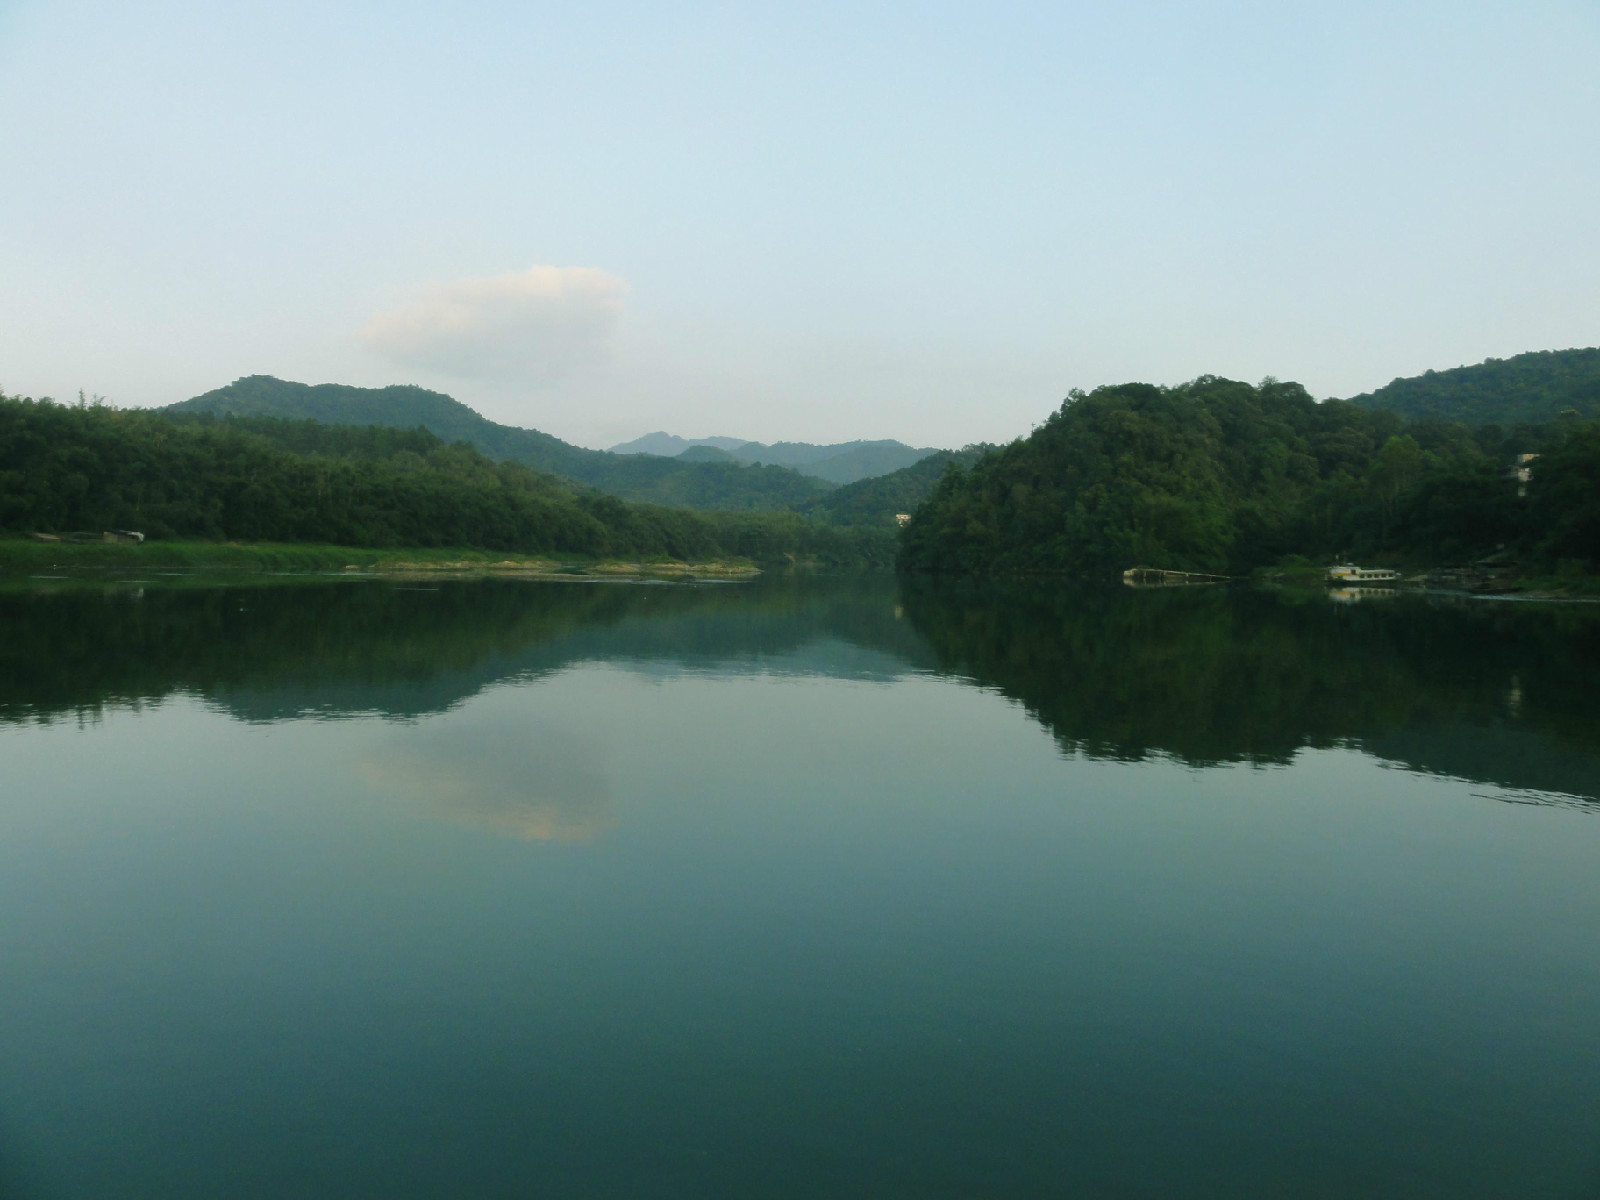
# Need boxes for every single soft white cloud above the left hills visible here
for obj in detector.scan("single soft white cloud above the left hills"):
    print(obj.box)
[360,267,627,382]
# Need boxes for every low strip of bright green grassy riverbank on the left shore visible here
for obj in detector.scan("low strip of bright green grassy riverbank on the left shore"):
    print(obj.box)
[0,538,762,579]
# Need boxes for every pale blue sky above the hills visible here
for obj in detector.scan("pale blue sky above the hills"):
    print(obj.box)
[0,0,1600,445]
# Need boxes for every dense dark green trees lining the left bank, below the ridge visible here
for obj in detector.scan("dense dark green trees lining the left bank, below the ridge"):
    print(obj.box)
[0,397,890,562]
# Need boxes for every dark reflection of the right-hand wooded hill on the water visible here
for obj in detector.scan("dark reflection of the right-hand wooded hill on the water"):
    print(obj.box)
[904,579,1600,809]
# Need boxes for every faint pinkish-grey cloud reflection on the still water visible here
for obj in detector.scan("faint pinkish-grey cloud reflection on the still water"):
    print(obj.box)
[358,722,614,842]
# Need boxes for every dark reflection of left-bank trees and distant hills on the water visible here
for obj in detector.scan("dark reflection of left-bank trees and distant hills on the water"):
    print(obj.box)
[0,576,931,720]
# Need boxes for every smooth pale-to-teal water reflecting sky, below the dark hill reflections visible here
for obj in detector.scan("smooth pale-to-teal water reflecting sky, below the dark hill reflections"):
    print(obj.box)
[0,630,1600,1200]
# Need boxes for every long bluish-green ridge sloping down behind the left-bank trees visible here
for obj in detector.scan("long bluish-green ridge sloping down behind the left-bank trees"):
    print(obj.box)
[170,374,829,509]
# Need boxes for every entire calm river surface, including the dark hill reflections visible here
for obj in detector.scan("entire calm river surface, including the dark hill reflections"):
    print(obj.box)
[0,578,1600,1200]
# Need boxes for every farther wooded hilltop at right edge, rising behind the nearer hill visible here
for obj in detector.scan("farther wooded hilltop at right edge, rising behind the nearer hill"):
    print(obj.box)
[1350,349,1600,426]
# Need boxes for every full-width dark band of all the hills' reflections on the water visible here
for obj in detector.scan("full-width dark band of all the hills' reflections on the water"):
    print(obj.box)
[0,576,1600,812]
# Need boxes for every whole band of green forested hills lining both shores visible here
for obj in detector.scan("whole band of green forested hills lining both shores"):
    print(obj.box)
[9,349,1600,589]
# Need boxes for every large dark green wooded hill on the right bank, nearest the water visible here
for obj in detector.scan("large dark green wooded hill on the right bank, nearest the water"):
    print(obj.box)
[901,376,1600,574]
